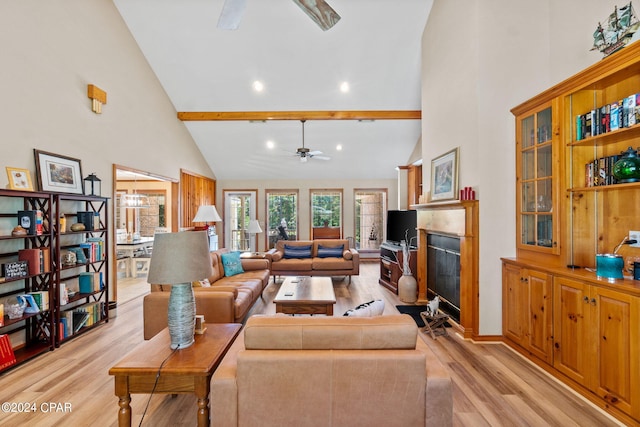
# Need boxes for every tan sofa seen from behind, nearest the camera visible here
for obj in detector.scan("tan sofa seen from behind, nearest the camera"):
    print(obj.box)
[211,315,453,427]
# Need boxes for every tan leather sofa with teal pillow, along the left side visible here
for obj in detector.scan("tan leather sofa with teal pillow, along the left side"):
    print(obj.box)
[143,249,269,340]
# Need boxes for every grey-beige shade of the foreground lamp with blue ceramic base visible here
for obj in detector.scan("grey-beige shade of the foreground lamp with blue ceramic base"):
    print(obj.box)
[147,231,213,285]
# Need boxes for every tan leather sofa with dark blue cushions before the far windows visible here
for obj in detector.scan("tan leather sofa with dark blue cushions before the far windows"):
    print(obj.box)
[267,239,360,282]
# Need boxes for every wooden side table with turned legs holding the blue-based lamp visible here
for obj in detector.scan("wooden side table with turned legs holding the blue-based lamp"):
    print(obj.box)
[109,323,242,427]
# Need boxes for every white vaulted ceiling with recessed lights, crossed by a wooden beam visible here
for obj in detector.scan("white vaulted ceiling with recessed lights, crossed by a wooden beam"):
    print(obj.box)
[114,0,432,180]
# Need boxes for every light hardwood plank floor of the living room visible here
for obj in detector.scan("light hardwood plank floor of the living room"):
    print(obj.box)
[0,263,618,427]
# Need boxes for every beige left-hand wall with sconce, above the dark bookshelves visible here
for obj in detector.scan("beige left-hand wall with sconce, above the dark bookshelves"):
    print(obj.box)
[0,0,213,195]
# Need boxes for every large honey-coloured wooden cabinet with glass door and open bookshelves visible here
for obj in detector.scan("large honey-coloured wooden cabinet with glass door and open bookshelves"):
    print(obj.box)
[503,43,640,425]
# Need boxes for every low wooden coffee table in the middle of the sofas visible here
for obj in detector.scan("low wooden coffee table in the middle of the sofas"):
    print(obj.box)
[273,276,336,316]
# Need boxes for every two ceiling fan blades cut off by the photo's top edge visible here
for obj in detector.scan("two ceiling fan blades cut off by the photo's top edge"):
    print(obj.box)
[218,0,340,31]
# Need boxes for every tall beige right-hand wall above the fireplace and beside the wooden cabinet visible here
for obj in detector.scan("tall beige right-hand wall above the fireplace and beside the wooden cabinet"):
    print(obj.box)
[422,0,619,335]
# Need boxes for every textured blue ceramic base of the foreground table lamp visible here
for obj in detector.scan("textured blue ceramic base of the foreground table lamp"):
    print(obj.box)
[168,283,196,350]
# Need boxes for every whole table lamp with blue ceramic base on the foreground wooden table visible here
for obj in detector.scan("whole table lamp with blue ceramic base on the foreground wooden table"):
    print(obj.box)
[147,231,213,349]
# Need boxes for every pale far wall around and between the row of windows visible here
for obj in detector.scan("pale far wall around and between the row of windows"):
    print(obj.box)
[222,179,398,250]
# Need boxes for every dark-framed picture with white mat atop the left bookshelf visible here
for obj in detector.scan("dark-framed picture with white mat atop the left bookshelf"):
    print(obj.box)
[33,149,84,194]
